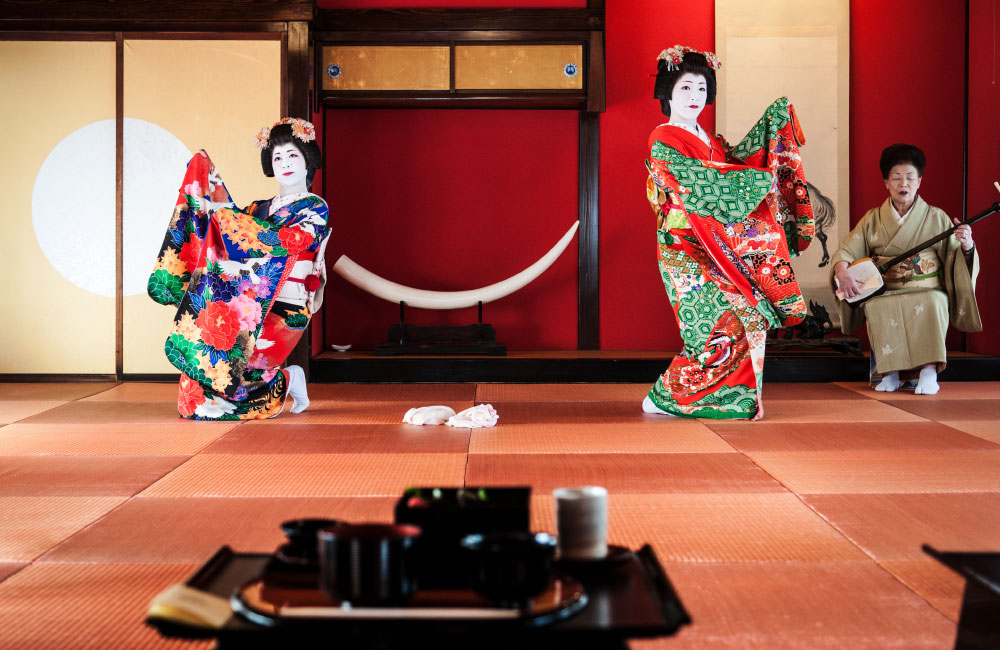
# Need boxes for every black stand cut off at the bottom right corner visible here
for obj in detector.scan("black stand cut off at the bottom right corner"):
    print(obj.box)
[923,544,1000,650]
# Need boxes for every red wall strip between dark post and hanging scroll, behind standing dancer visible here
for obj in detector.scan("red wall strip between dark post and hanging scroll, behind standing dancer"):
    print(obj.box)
[600,0,715,350]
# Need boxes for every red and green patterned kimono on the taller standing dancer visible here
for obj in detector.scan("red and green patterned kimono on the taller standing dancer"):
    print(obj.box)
[646,98,813,419]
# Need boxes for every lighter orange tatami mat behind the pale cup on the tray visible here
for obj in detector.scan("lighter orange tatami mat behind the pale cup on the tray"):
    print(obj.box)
[531,493,867,562]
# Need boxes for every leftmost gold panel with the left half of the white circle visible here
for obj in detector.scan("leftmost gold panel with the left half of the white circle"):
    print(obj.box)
[0,41,115,374]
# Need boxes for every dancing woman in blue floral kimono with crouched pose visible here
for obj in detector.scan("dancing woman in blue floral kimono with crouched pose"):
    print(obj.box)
[147,118,329,420]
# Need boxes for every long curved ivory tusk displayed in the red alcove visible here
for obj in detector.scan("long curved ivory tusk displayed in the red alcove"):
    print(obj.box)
[333,221,580,309]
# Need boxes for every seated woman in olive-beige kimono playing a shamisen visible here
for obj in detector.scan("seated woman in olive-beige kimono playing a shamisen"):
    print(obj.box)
[831,144,983,395]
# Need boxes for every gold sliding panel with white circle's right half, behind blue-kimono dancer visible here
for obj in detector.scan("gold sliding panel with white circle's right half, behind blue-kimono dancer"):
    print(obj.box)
[122,38,282,374]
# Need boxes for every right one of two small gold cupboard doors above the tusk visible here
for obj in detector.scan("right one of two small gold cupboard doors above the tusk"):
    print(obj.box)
[455,45,584,90]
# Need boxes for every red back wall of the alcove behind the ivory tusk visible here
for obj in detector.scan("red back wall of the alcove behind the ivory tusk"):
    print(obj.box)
[312,109,579,350]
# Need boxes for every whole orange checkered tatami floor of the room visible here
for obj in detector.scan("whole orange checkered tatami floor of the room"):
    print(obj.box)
[0,382,1000,650]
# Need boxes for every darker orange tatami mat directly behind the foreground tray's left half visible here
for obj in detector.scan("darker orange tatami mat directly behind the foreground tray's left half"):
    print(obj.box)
[42,497,397,562]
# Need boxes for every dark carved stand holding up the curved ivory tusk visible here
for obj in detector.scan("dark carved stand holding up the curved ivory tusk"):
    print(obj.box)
[375,301,507,357]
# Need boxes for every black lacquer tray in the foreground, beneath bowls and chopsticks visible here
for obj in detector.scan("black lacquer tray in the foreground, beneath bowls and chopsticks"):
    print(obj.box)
[146,546,690,650]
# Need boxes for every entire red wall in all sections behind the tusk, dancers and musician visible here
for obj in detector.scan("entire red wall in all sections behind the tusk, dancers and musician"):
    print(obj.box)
[318,0,1000,354]
